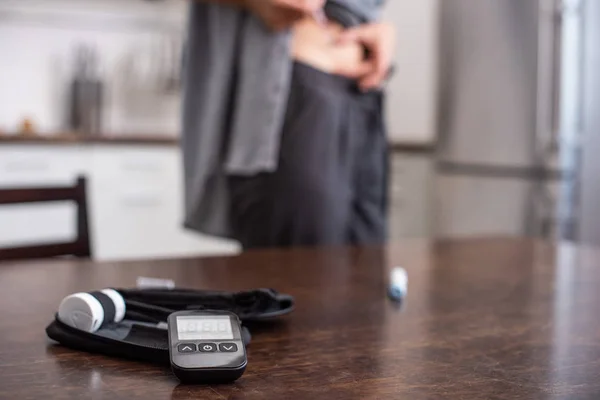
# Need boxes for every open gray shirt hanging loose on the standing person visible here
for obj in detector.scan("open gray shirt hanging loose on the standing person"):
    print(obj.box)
[182,0,382,237]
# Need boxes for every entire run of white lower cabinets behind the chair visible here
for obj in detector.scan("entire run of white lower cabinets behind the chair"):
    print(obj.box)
[0,144,239,260]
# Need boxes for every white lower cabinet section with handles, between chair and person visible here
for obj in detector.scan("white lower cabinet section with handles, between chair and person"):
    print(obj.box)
[90,146,238,259]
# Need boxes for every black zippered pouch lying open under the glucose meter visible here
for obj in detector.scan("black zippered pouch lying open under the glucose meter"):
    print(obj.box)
[46,289,294,364]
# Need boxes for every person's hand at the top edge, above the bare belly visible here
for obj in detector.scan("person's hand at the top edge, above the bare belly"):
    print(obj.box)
[245,0,325,31]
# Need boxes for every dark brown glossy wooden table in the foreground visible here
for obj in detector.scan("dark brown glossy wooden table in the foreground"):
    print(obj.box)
[0,239,600,400]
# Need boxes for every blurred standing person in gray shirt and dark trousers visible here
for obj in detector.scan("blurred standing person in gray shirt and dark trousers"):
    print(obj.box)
[182,0,394,249]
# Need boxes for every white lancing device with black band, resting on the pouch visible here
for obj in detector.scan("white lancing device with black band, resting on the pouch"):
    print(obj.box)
[58,289,125,333]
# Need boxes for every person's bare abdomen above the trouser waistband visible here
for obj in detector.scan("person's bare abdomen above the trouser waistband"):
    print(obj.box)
[292,18,364,74]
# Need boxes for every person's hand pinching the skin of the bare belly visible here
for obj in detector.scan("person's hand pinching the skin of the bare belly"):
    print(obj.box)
[338,23,396,91]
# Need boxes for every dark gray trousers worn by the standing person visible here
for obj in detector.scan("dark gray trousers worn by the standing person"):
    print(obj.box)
[229,63,389,249]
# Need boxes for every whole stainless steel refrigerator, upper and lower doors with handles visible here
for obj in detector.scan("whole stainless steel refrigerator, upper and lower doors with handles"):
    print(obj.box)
[436,0,594,239]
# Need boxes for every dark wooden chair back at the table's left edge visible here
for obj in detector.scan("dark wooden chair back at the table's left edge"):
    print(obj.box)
[0,177,92,261]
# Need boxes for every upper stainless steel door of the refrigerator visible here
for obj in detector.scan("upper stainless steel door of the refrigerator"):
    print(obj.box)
[438,0,554,168]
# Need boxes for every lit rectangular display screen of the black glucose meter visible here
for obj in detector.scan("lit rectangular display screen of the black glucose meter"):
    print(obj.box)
[177,315,233,340]
